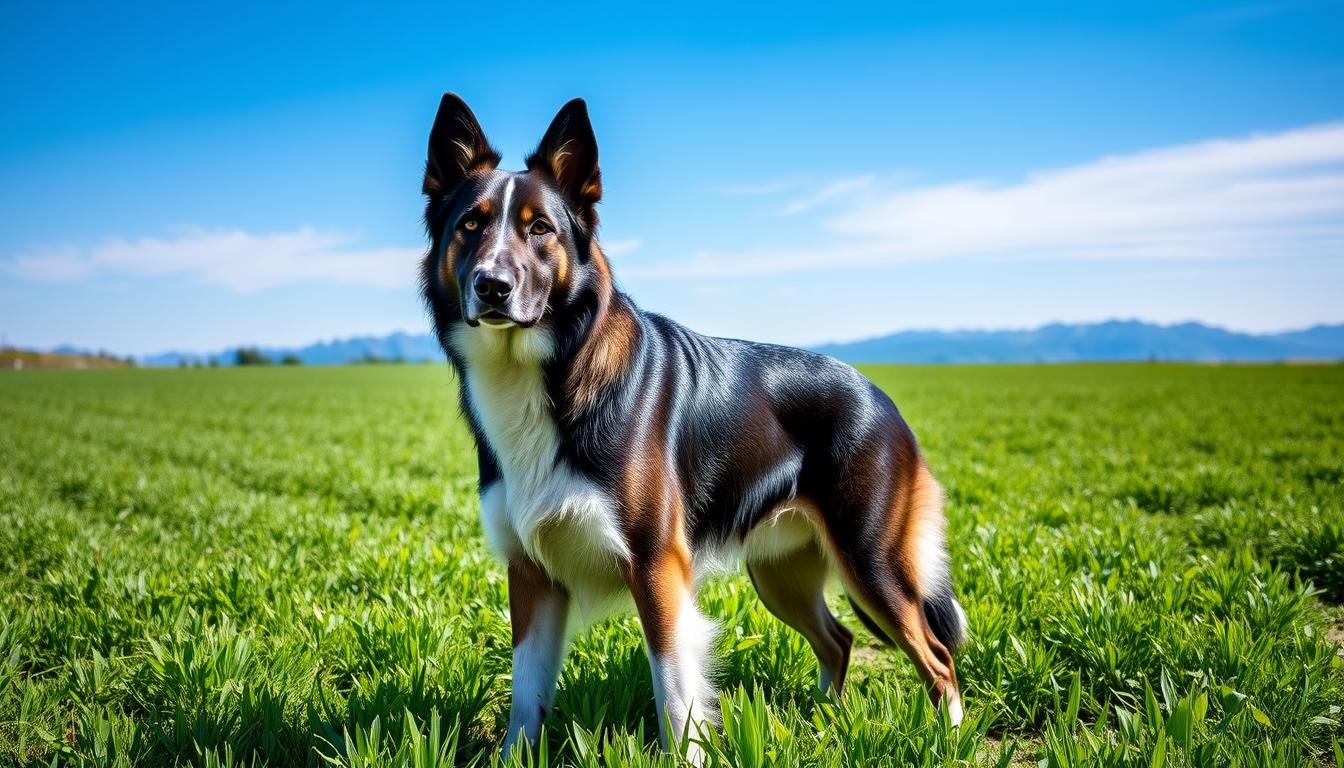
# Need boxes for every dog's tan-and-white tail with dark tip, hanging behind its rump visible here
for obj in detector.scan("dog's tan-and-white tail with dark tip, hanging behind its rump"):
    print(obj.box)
[903,463,966,651]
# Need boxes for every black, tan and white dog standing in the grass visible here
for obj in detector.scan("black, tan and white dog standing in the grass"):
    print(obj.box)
[421,93,966,760]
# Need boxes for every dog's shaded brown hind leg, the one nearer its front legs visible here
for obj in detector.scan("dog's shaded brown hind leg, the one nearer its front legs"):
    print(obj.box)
[747,541,853,695]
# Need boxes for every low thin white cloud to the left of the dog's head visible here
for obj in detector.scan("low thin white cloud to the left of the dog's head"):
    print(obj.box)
[0,227,425,292]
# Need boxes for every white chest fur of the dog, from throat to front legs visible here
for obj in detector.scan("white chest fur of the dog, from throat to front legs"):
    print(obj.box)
[453,325,629,603]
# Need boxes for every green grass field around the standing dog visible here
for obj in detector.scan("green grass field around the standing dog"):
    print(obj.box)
[0,366,1344,768]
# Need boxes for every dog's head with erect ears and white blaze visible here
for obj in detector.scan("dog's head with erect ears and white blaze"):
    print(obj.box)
[423,93,602,328]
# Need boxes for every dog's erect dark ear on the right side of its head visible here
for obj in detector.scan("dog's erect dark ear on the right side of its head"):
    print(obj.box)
[527,98,602,227]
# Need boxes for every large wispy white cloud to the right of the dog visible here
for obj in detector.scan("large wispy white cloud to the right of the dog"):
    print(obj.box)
[626,124,1344,277]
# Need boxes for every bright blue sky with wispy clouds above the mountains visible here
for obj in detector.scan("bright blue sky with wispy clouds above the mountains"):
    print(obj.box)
[0,1,1344,354]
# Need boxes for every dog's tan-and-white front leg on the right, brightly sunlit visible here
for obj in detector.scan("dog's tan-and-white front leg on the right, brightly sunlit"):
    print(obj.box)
[628,550,718,764]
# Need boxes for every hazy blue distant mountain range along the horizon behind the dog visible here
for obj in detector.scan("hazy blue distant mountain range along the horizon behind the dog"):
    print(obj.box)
[52,320,1344,366]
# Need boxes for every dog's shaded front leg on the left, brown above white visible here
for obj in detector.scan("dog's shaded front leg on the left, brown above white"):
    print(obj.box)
[504,557,570,759]
